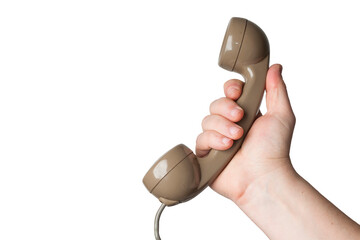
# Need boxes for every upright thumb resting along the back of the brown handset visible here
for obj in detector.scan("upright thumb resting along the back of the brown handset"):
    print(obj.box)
[266,64,294,117]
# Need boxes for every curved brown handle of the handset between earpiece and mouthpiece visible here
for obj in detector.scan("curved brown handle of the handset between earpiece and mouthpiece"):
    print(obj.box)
[198,56,269,189]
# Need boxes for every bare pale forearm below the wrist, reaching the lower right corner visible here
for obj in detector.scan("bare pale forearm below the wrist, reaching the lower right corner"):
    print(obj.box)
[236,164,360,240]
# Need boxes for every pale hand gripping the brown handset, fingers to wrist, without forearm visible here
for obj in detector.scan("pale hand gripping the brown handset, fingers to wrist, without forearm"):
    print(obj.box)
[196,64,295,204]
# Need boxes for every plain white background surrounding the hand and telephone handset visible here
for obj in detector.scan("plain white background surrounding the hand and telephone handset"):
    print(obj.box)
[0,0,360,240]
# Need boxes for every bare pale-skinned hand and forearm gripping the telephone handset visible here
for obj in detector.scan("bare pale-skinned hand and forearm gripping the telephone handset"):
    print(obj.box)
[196,64,360,240]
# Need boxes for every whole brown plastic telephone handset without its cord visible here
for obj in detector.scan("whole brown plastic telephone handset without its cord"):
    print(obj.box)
[143,18,270,206]
